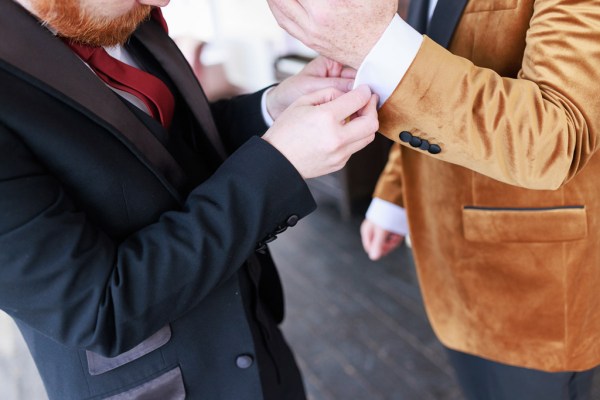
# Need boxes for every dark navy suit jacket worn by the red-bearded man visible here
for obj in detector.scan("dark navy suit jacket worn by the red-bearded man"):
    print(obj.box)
[0,0,314,400]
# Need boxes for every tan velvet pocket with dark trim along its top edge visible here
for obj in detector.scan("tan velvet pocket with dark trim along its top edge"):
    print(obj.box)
[462,206,587,243]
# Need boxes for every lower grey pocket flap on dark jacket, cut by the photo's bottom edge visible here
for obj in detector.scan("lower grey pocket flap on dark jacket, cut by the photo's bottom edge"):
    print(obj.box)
[105,367,185,400]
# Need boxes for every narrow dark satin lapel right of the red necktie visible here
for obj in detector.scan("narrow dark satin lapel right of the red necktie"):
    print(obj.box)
[134,21,227,159]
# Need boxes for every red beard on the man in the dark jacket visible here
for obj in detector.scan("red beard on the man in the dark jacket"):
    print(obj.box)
[33,0,152,46]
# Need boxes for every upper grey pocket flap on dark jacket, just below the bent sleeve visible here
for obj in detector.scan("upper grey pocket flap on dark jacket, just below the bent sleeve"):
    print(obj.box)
[85,325,171,376]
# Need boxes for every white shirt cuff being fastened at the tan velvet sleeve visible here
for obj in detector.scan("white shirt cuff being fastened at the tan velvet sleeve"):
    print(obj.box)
[354,15,423,107]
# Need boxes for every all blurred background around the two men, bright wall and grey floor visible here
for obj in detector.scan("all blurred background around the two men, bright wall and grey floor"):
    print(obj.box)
[0,0,468,400]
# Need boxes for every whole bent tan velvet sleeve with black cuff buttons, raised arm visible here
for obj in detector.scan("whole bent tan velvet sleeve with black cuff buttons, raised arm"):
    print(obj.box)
[380,0,600,189]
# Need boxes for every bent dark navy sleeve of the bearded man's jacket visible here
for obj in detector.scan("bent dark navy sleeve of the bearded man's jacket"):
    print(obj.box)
[0,124,315,356]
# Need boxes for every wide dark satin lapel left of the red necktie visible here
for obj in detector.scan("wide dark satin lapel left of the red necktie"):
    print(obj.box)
[0,0,184,199]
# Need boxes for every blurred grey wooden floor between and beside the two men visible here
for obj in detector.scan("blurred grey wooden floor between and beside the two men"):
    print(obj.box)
[0,195,600,400]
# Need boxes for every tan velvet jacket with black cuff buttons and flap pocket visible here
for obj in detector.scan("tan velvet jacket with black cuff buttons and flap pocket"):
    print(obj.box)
[375,0,600,371]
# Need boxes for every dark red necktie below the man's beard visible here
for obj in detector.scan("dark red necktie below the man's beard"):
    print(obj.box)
[65,8,175,129]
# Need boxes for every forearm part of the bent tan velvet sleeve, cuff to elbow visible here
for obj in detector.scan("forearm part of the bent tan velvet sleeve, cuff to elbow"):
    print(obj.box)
[380,41,600,189]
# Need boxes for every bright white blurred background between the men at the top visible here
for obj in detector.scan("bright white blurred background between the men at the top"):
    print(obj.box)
[163,0,315,98]
